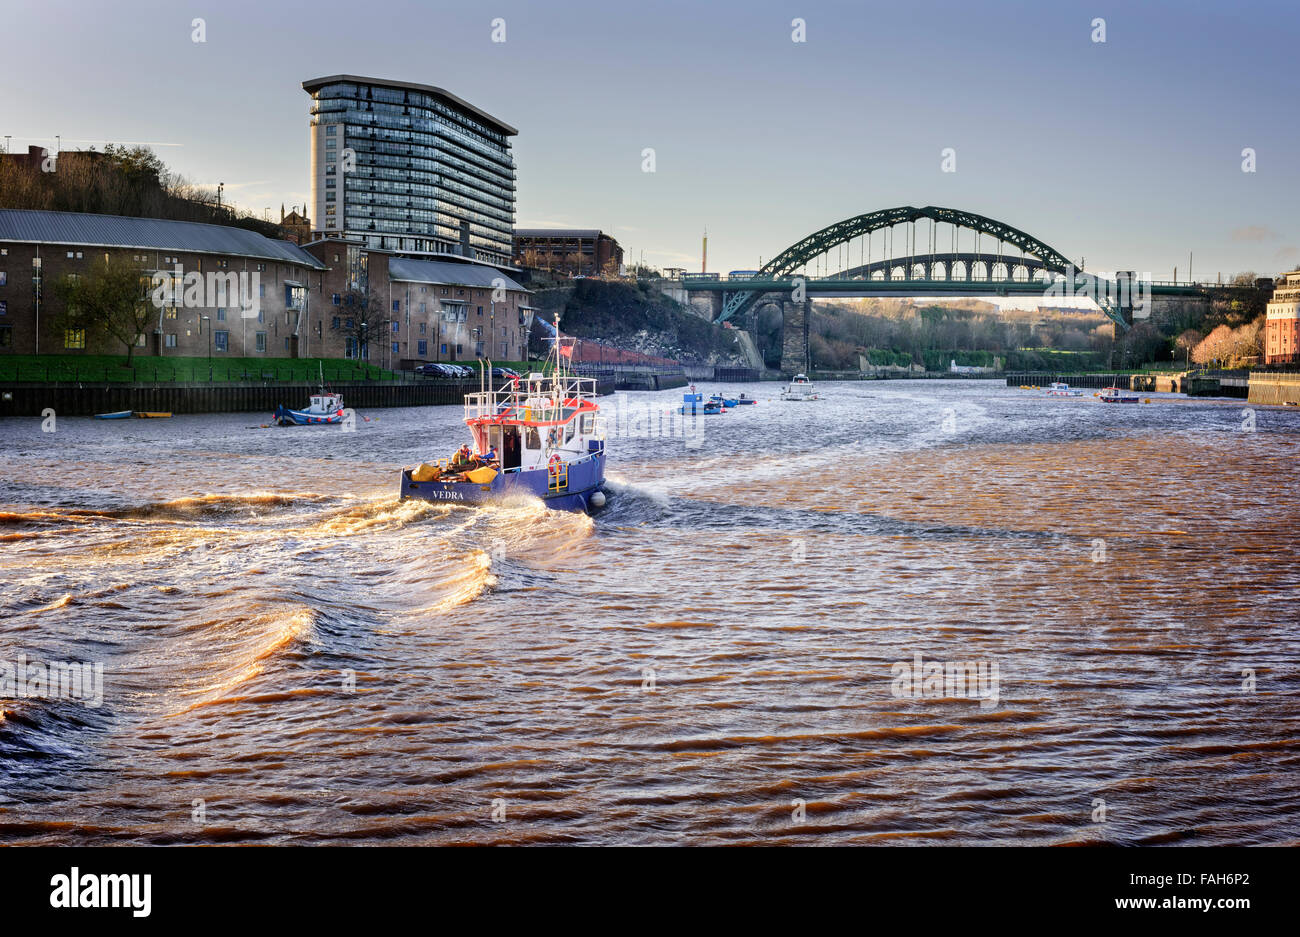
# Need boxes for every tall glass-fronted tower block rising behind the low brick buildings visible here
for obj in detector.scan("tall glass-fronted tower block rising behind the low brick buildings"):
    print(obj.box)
[303,77,515,264]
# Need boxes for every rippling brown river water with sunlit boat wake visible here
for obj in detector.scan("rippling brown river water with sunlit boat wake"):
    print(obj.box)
[0,381,1300,845]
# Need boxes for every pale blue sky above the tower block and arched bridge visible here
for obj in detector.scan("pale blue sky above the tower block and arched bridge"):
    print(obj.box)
[0,0,1300,278]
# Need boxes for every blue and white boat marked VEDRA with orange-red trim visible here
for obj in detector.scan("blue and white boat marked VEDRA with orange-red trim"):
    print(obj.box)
[400,337,605,511]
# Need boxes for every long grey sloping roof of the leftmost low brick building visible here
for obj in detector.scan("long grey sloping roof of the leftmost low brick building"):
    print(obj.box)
[0,208,326,270]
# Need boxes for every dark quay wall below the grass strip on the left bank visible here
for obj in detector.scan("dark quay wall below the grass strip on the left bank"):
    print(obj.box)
[0,381,614,417]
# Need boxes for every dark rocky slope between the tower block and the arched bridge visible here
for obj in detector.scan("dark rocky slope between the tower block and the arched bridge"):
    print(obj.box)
[533,279,745,366]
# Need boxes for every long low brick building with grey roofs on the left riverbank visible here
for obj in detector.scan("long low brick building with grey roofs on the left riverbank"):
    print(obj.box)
[0,211,532,368]
